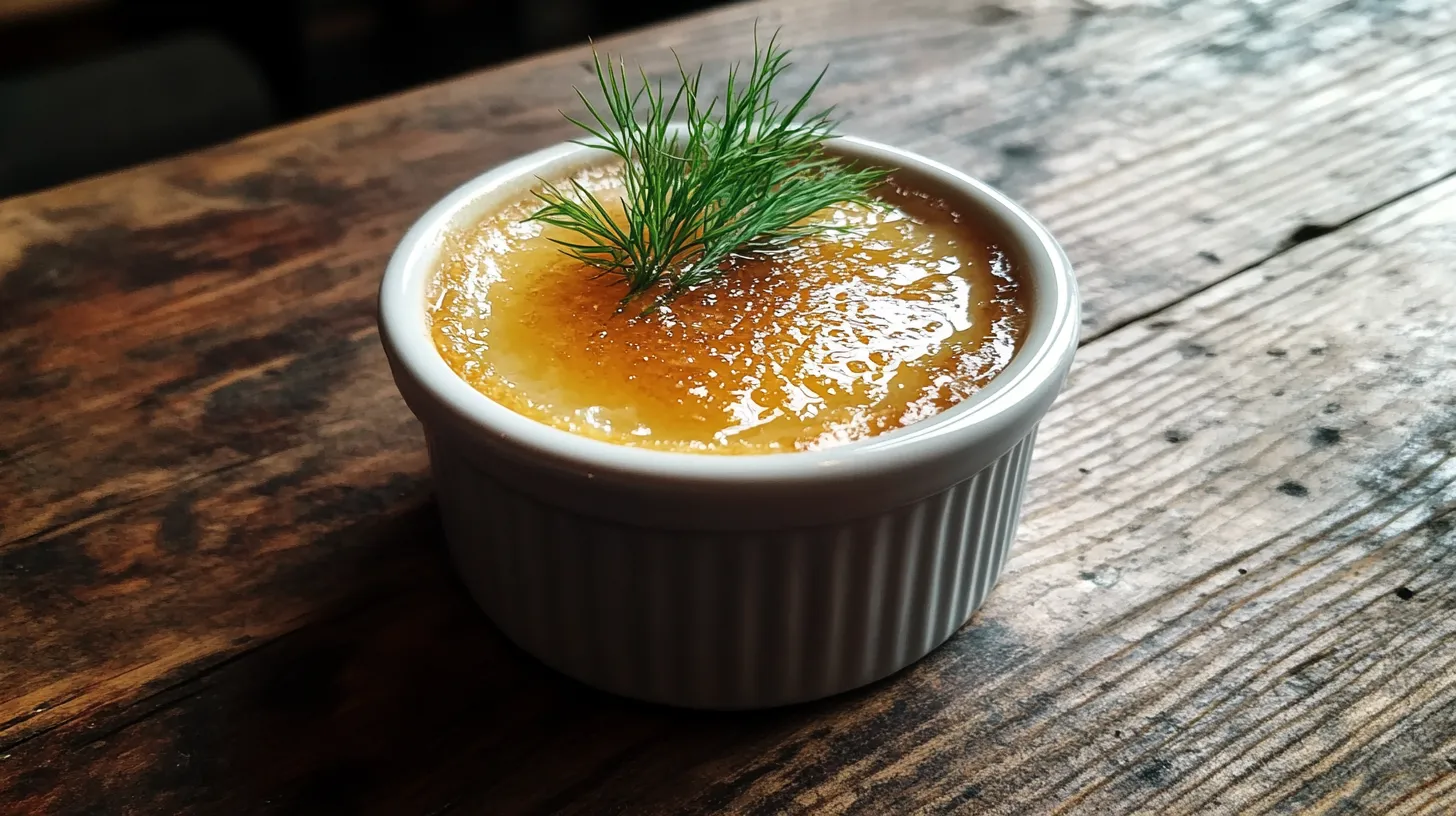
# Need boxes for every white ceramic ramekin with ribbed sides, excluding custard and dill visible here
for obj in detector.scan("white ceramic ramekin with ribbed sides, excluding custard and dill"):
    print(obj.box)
[380,137,1079,708]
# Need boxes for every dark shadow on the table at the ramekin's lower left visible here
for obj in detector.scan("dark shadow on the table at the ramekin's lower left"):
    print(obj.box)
[189,504,879,813]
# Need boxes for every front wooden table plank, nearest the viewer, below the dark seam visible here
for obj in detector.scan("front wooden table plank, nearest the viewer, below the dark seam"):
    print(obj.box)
[0,116,1456,813]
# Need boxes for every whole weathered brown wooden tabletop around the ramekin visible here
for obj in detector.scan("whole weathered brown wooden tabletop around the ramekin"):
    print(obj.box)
[0,0,1456,815]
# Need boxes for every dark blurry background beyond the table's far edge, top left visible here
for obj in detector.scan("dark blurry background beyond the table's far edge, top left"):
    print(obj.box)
[0,0,722,197]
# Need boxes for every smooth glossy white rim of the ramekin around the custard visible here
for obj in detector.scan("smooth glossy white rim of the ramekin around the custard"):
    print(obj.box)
[379,136,1079,485]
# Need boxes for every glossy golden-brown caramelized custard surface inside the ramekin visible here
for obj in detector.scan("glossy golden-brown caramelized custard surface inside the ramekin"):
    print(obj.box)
[428,168,1026,453]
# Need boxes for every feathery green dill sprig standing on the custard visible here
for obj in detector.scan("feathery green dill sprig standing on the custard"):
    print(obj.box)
[531,35,885,310]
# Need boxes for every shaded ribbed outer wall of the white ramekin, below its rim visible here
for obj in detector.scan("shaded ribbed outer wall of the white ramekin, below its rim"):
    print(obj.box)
[431,433,1035,708]
